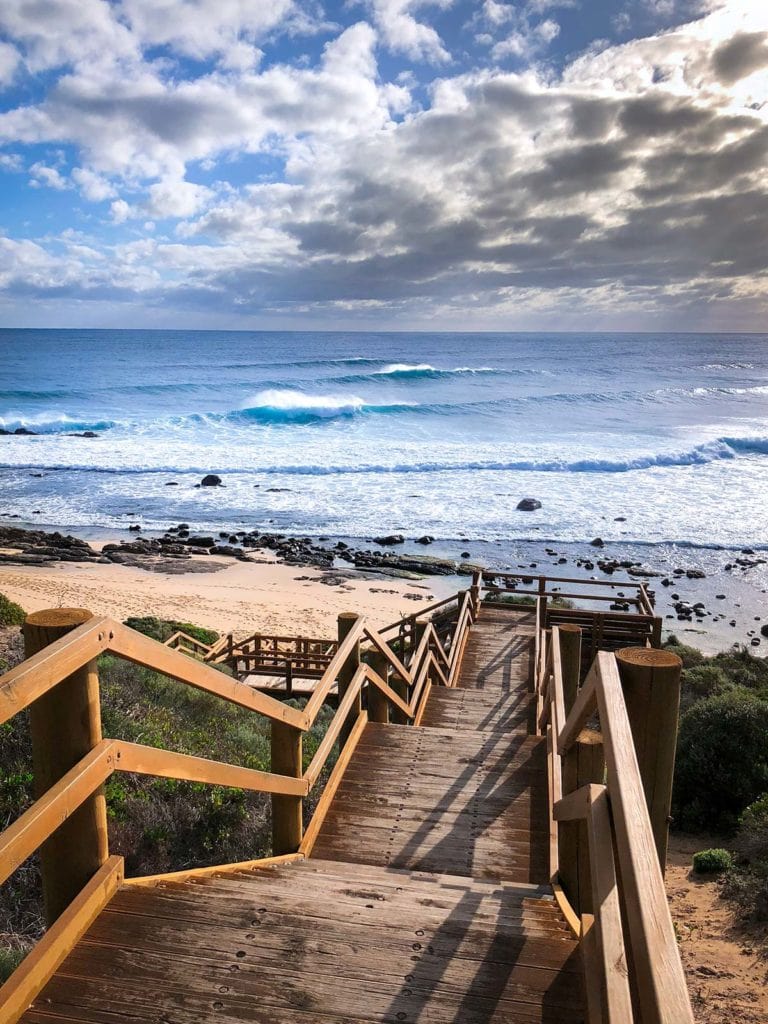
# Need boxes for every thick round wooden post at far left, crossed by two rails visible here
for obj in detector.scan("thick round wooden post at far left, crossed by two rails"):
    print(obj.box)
[24,608,109,925]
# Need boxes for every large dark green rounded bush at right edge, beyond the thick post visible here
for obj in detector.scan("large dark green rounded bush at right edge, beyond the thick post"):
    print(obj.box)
[673,687,768,833]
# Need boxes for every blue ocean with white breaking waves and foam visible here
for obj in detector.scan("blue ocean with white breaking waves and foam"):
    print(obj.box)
[0,330,768,548]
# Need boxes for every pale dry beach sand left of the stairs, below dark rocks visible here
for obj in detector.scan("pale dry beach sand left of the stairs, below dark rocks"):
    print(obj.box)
[0,553,455,637]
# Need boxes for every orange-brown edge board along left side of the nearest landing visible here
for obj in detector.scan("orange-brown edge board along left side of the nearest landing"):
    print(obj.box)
[0,857,123,1024]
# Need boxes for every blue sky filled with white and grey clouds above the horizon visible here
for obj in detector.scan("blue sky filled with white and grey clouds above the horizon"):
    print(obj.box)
[0,0,768,331]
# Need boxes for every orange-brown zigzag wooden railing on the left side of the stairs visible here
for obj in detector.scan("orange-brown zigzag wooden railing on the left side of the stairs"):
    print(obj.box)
[0,592,473,1024]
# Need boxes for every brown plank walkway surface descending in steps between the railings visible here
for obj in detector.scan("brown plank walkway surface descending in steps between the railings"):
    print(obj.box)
[22,608,585,1024]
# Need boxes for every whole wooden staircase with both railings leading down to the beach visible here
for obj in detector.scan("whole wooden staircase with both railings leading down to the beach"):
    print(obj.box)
[0,574,693,1024]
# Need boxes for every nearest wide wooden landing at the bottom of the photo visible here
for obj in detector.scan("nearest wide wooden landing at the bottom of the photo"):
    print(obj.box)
[23,860,584,1024]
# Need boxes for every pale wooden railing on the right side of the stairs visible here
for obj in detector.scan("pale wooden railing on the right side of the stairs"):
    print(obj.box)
[536,606,693,1024]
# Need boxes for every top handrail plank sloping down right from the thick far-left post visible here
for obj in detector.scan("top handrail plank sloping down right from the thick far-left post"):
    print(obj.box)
[108,621,311,729]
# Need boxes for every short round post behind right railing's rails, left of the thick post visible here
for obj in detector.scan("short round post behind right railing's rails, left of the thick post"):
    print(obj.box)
[558,729,605,913]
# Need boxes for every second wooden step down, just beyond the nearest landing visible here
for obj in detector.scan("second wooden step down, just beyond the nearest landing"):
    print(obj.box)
[313,723,549,884]
